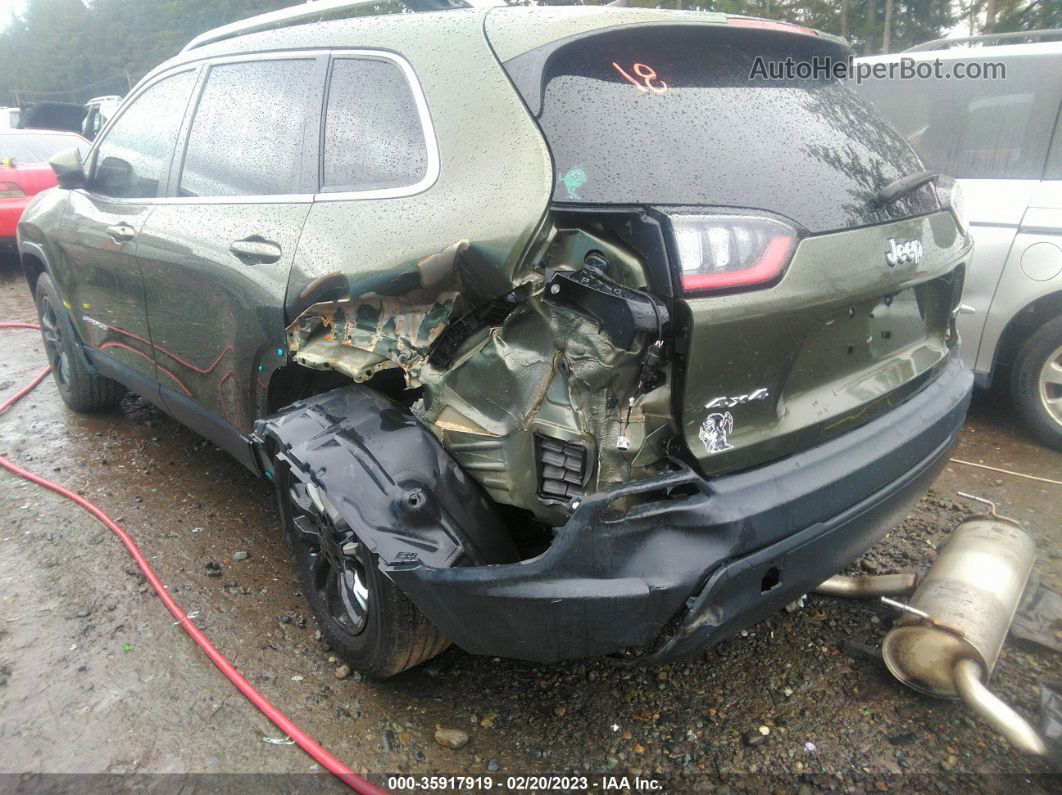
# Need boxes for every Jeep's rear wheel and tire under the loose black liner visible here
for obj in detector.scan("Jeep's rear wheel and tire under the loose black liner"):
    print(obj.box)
[274,462,450,678]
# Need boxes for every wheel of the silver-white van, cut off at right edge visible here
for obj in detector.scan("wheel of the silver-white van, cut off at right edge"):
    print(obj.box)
[1011,317,1062,450]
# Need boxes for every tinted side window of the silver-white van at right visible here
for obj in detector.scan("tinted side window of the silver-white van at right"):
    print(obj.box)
[856,53,1062,179]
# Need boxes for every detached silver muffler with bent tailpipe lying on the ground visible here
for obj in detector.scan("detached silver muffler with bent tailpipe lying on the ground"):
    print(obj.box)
[879,503,1046,755]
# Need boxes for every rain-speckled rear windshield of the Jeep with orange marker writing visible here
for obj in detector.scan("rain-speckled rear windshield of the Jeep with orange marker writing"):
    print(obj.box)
[506,25,938,232]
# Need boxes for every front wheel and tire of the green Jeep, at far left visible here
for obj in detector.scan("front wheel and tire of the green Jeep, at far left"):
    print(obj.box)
[33,273,125,412]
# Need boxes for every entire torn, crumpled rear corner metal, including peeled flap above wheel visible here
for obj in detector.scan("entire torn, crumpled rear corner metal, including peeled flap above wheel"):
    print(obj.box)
[288,225,676,524]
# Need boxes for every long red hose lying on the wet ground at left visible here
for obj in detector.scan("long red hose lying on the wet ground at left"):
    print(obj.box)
[0,323,386,795]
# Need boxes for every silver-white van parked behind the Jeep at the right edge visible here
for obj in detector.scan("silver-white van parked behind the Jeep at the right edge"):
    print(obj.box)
[853,31,1062,449]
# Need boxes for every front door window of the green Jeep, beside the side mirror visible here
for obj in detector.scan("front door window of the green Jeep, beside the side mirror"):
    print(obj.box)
[89,71,195,198]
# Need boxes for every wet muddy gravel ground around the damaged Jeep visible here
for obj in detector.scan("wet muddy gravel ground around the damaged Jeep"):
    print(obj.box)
[0,269,1062,792]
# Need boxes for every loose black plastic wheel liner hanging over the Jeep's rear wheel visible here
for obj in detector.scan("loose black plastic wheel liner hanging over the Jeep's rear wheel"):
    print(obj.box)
[254,384,518,574]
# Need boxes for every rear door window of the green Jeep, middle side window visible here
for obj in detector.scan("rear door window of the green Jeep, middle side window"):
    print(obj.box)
[177,58,319,196]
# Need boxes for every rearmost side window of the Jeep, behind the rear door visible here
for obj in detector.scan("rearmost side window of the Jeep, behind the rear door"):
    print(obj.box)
[322,57,428,192]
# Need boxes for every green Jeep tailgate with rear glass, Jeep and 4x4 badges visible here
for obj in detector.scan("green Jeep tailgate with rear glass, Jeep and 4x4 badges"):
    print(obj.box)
[487,14,969,473]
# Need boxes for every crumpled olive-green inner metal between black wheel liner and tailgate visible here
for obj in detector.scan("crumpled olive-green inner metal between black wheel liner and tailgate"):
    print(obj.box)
[421,292,671,523]
